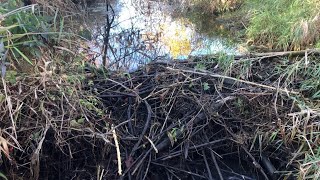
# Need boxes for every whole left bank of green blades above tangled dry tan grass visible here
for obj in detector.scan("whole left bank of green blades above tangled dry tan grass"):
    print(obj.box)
[0,0,101,179]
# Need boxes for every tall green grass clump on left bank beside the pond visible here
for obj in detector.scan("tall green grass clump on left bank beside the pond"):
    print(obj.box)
[0,0,85,73]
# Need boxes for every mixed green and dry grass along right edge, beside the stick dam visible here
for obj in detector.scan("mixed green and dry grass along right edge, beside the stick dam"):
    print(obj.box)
[275,55,320,180]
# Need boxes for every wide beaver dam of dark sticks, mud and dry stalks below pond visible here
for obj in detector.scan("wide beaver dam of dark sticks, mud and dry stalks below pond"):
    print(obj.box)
[2,50,319,179]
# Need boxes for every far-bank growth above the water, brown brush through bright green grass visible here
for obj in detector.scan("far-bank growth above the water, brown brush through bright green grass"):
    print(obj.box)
[175,0,320,50]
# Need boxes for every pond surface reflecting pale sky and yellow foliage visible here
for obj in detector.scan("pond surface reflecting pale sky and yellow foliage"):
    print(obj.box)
[84,0,238,70]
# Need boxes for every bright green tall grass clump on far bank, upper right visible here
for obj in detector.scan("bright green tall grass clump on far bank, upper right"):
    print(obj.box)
[243,0,320,50]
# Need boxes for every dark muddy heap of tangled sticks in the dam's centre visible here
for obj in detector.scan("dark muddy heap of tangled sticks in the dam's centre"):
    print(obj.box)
[87,58,296,179]
